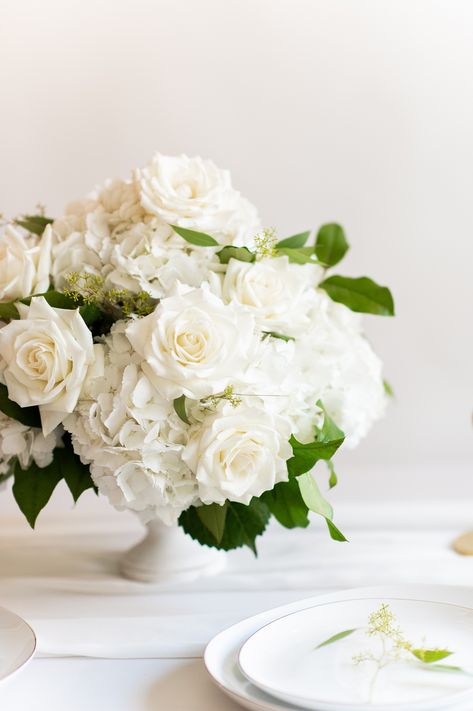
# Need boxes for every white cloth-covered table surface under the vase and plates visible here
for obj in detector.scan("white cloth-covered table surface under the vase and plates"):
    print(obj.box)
[0,501,473,711]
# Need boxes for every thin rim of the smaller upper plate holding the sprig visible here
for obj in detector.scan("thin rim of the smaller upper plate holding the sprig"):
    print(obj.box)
[236,596,473,711]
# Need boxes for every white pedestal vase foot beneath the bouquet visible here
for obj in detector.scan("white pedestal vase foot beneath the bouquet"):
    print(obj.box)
[120,521,226,583]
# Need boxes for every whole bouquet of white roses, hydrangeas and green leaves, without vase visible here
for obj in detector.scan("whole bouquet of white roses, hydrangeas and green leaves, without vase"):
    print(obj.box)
[0,154,394,550]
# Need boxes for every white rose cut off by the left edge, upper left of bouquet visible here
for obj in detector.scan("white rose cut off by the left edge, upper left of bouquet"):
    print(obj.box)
[0,225,52,301]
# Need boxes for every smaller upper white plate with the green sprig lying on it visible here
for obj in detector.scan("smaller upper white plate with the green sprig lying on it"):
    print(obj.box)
[239,597,473,711]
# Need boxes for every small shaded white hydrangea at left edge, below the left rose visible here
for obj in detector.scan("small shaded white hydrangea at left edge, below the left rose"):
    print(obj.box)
[0,412,61,475]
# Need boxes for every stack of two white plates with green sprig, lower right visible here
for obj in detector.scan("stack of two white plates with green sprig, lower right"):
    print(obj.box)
[205,586,473,711]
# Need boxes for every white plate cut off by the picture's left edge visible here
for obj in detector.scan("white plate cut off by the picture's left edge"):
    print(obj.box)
[0,607,36,683]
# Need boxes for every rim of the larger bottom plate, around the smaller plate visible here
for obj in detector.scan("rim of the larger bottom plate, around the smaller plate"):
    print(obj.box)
[203,582,473,711]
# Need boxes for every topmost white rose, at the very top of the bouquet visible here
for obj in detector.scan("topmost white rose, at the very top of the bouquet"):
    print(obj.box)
[137,153,240,233]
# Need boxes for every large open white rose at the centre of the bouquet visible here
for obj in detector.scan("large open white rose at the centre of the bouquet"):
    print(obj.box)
[127,288,258,399]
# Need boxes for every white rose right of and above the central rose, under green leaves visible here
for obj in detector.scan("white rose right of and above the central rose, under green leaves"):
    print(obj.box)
[222,257,321,335]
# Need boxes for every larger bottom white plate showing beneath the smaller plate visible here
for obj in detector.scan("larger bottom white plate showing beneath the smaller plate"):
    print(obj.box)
[204,585,473,711]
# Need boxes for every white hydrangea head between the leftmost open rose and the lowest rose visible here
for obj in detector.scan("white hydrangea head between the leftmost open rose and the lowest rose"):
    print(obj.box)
[65,322,197,524]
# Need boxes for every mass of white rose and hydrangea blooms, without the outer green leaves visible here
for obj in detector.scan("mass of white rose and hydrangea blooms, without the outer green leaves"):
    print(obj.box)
[0,154,385,524]
